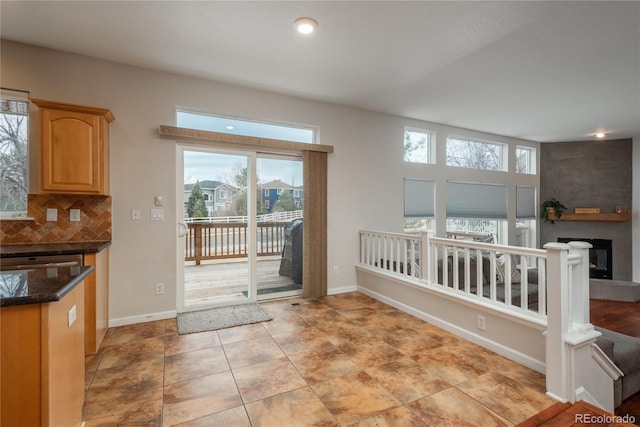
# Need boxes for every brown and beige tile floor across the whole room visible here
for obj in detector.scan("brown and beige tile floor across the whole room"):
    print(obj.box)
[84,292,554,427]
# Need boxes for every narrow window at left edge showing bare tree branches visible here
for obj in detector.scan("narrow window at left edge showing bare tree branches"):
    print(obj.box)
[0,95,29,217]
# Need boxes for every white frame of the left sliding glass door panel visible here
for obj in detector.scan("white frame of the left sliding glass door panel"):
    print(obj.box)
[176,145,257,313]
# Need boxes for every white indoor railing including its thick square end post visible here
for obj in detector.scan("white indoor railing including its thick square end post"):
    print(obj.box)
[358,230,621,412]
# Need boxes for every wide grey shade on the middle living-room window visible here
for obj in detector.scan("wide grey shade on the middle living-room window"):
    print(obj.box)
[447,182,507,219]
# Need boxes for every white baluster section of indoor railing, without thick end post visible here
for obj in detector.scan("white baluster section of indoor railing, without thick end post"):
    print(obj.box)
[360,230,546,316]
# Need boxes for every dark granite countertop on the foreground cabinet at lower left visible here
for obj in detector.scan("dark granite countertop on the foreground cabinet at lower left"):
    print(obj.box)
[0,266,94,307]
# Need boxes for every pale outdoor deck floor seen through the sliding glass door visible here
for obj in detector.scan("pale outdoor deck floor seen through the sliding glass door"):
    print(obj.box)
[184,256,302,306]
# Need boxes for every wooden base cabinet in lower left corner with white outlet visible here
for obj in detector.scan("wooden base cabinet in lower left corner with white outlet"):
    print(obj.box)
[0,283,85,427]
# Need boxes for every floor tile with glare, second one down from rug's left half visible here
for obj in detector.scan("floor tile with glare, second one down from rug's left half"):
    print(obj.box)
[164,346,231,385]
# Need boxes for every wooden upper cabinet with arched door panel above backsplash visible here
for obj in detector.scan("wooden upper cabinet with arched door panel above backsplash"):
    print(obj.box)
[31,99,114,194]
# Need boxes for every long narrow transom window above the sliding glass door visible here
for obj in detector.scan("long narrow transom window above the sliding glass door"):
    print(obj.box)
[176,111,316,144]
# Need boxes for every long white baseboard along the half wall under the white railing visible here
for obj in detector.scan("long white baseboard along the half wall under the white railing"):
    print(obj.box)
[358,287,546,374]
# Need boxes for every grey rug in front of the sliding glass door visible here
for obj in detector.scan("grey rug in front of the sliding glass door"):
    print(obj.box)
[178,304,273,335]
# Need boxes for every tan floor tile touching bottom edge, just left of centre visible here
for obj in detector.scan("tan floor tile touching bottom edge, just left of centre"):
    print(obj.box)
[247,387,339,427]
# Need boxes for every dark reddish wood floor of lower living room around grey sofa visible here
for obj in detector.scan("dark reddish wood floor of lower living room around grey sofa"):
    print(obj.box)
[591,299,640,423]
